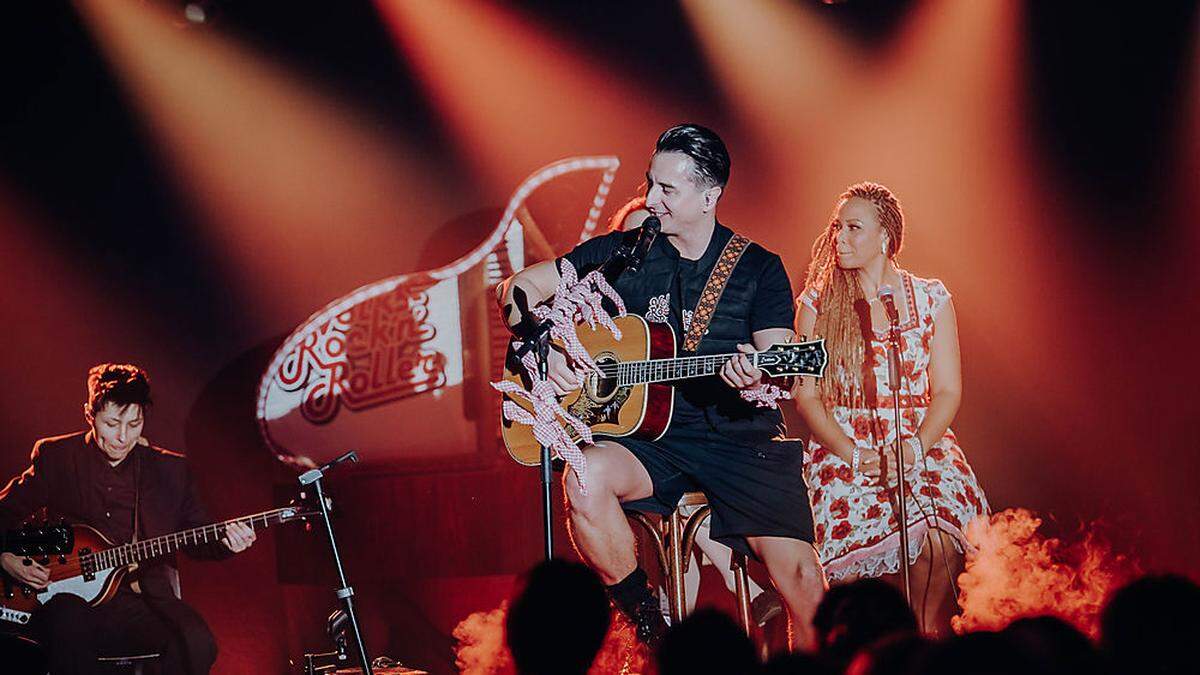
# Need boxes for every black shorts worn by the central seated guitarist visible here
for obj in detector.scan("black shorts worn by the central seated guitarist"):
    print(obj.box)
[610,428,814,557]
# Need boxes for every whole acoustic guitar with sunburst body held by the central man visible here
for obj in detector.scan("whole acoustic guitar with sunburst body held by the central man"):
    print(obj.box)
[500,315,828,466]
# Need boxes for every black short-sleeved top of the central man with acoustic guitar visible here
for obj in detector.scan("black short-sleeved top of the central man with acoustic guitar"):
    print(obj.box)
[563,223,794,437]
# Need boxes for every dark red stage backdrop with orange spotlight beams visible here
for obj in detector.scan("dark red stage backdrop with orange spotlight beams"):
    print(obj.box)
[0,0,1200,673]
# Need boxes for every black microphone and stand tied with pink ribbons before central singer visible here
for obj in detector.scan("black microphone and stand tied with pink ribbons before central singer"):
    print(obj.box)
[514,216,662,560]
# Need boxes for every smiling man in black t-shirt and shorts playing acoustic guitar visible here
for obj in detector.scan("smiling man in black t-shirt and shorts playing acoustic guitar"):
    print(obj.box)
[499,125,824,647]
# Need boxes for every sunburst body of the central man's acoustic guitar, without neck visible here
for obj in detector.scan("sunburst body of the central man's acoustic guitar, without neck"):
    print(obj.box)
[500,315,676,466]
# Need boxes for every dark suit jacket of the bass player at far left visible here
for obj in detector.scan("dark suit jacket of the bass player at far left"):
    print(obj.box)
[0,431,233,597]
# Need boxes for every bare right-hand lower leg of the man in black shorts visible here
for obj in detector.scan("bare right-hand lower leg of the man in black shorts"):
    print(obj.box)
[746,537,827,651]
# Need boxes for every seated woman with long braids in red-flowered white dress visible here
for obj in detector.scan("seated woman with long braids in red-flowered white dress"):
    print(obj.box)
[796,183,988,633]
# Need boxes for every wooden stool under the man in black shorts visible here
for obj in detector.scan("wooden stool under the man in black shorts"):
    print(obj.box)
[625,492,752,634]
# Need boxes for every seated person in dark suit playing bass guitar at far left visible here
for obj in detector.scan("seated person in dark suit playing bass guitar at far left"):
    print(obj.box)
[0,364,254,675]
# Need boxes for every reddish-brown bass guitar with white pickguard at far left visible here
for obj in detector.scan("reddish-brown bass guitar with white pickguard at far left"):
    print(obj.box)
[0,506,317,625]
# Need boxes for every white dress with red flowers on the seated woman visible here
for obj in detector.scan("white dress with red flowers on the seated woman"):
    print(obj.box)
[800,271,988,580]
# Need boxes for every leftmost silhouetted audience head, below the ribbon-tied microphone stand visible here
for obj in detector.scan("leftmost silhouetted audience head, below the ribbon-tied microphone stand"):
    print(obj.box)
[504,560,611,675]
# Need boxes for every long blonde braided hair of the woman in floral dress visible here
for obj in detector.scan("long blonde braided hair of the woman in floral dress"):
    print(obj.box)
[805,183,904,407]
